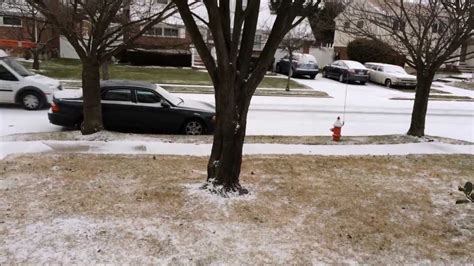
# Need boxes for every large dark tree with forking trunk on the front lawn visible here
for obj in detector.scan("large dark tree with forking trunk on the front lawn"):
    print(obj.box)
[173,0,320,195]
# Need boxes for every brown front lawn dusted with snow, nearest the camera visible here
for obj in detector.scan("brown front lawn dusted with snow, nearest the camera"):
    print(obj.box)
[0,154,474,264]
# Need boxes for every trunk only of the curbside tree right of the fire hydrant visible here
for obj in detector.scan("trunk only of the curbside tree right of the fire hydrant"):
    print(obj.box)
[407,69,434,137]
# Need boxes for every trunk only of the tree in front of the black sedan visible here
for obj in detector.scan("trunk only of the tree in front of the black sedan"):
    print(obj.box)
[81,58,104,135]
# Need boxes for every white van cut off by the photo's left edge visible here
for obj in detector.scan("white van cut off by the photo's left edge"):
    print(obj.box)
[0,50,62,110]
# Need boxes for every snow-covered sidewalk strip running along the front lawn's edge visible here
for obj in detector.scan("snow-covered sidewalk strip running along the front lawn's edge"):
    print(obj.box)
[0,141,474,159]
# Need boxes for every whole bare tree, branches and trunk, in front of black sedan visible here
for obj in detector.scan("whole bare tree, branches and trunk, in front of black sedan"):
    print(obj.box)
[27,0,180,134]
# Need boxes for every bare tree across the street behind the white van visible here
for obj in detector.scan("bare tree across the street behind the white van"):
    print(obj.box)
[0,1,53,70]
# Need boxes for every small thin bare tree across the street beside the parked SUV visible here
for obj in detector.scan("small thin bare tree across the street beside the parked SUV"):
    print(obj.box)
[277,20,314,91]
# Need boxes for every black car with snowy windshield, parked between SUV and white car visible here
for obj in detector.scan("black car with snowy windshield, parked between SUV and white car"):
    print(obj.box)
[322,60,369,85]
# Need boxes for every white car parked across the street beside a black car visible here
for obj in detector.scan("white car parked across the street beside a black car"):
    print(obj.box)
[365,62,416,89]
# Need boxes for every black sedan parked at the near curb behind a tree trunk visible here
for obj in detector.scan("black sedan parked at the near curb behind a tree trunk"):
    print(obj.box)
[48,80,215,135]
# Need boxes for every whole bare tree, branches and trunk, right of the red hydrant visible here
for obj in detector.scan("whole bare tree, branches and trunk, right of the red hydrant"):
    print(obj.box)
[341,0,474,136]
